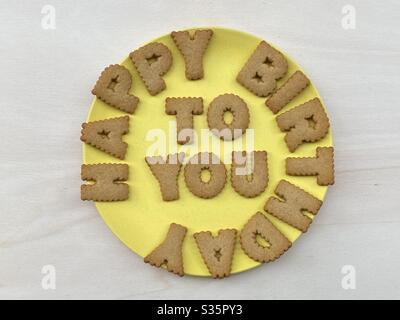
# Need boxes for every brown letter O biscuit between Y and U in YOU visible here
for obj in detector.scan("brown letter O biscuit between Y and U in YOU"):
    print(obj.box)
[184,152,226,199]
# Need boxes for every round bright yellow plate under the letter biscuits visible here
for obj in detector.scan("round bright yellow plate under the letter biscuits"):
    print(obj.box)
[83,28,332,276]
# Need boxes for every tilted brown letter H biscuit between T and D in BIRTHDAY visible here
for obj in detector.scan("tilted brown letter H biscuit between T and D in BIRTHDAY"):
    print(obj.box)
[264,180,322,232]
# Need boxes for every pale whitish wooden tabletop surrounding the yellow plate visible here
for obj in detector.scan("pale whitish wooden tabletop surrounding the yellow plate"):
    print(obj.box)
[0,0,400,299]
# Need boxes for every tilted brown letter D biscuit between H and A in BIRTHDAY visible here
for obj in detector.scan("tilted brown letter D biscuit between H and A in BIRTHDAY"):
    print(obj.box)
[240,212,292,262]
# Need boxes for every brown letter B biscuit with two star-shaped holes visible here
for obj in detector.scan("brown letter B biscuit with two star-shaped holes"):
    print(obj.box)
[236,41,288,97]
